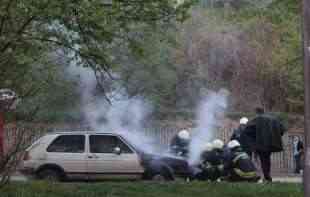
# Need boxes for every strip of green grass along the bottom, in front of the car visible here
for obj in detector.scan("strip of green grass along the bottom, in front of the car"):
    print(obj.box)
[0,181,303,197]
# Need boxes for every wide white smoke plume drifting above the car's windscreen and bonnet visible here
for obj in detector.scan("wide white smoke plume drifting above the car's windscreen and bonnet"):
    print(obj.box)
[69,65,157,153]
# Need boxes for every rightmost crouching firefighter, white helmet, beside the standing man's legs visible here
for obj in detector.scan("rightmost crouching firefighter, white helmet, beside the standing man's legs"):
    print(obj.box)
[225,140,260,182]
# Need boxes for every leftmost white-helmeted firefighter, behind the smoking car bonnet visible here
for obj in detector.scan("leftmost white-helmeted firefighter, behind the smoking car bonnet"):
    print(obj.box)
[170,129,190,157]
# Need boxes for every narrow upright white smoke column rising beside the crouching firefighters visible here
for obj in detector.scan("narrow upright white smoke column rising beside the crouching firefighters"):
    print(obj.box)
[189,89,228,164]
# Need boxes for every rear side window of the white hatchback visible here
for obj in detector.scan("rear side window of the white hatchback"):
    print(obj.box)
[47,135,85,153]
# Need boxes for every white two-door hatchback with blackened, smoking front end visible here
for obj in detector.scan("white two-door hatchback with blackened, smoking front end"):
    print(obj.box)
[20,132,190,180]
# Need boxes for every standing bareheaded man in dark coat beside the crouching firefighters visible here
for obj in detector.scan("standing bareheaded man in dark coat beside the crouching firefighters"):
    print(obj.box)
[246,108,285,182]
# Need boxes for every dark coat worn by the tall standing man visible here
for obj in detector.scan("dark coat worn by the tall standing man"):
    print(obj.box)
[245,114,285,152]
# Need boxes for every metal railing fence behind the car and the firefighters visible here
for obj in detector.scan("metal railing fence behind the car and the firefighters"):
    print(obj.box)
[4,124,304,174]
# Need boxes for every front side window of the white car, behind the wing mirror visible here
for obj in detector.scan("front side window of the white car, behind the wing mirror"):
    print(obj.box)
[89,135,133,153]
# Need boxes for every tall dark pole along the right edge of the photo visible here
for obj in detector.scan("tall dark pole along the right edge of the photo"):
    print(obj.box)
[302,0,310,197]
